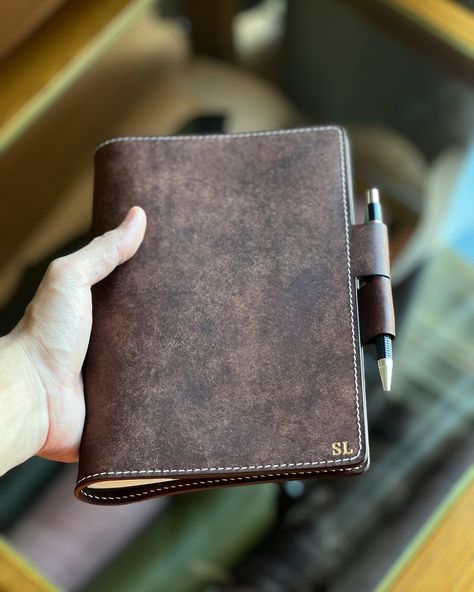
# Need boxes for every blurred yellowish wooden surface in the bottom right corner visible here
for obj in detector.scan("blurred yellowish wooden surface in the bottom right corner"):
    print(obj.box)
[377,467,474,592]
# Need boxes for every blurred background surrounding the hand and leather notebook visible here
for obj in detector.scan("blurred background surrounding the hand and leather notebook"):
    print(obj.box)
[0,0,474,592]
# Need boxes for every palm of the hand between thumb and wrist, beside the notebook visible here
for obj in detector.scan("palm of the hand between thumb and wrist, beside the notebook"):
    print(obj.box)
[23,259,92,461]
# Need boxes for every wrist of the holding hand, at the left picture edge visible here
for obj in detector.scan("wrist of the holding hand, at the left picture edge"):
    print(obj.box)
[0,330,49,475]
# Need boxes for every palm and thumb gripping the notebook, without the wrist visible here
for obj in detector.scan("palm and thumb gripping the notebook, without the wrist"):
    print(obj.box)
[19,208,146,461]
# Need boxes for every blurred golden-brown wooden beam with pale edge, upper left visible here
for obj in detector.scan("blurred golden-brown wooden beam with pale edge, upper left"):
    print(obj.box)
[0,0,150,151]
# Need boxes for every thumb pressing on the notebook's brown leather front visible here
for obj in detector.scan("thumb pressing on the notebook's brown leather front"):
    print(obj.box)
[63,206,146,286]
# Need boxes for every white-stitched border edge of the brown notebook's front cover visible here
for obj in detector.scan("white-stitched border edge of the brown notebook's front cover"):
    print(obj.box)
[76,125,362,490]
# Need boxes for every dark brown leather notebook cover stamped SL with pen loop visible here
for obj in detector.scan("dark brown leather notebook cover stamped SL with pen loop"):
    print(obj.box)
[75,126,393,504]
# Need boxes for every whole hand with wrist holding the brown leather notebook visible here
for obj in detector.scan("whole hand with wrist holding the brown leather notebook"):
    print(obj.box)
[0,207,146,474]
